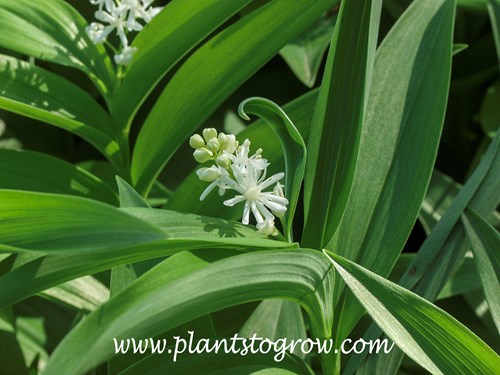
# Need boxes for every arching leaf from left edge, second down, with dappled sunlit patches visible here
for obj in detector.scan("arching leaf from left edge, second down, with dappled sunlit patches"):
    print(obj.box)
[0,55,122,169]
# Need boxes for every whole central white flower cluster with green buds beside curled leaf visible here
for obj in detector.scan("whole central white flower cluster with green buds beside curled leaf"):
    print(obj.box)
[189,128,288,236]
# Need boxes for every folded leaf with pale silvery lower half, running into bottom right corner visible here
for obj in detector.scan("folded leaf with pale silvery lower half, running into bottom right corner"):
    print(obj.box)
[325,252,500,375]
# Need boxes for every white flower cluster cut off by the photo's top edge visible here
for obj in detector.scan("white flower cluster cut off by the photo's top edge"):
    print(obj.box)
[86,0,162,65]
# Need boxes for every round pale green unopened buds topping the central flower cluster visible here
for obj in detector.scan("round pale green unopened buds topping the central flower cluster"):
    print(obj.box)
[189,128,238,169]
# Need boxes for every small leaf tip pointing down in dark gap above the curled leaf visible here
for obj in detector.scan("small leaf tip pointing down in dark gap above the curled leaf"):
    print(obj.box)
[280,15,337,87]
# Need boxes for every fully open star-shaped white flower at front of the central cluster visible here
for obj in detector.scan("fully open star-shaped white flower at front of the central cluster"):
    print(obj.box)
[224,164,288,225]
